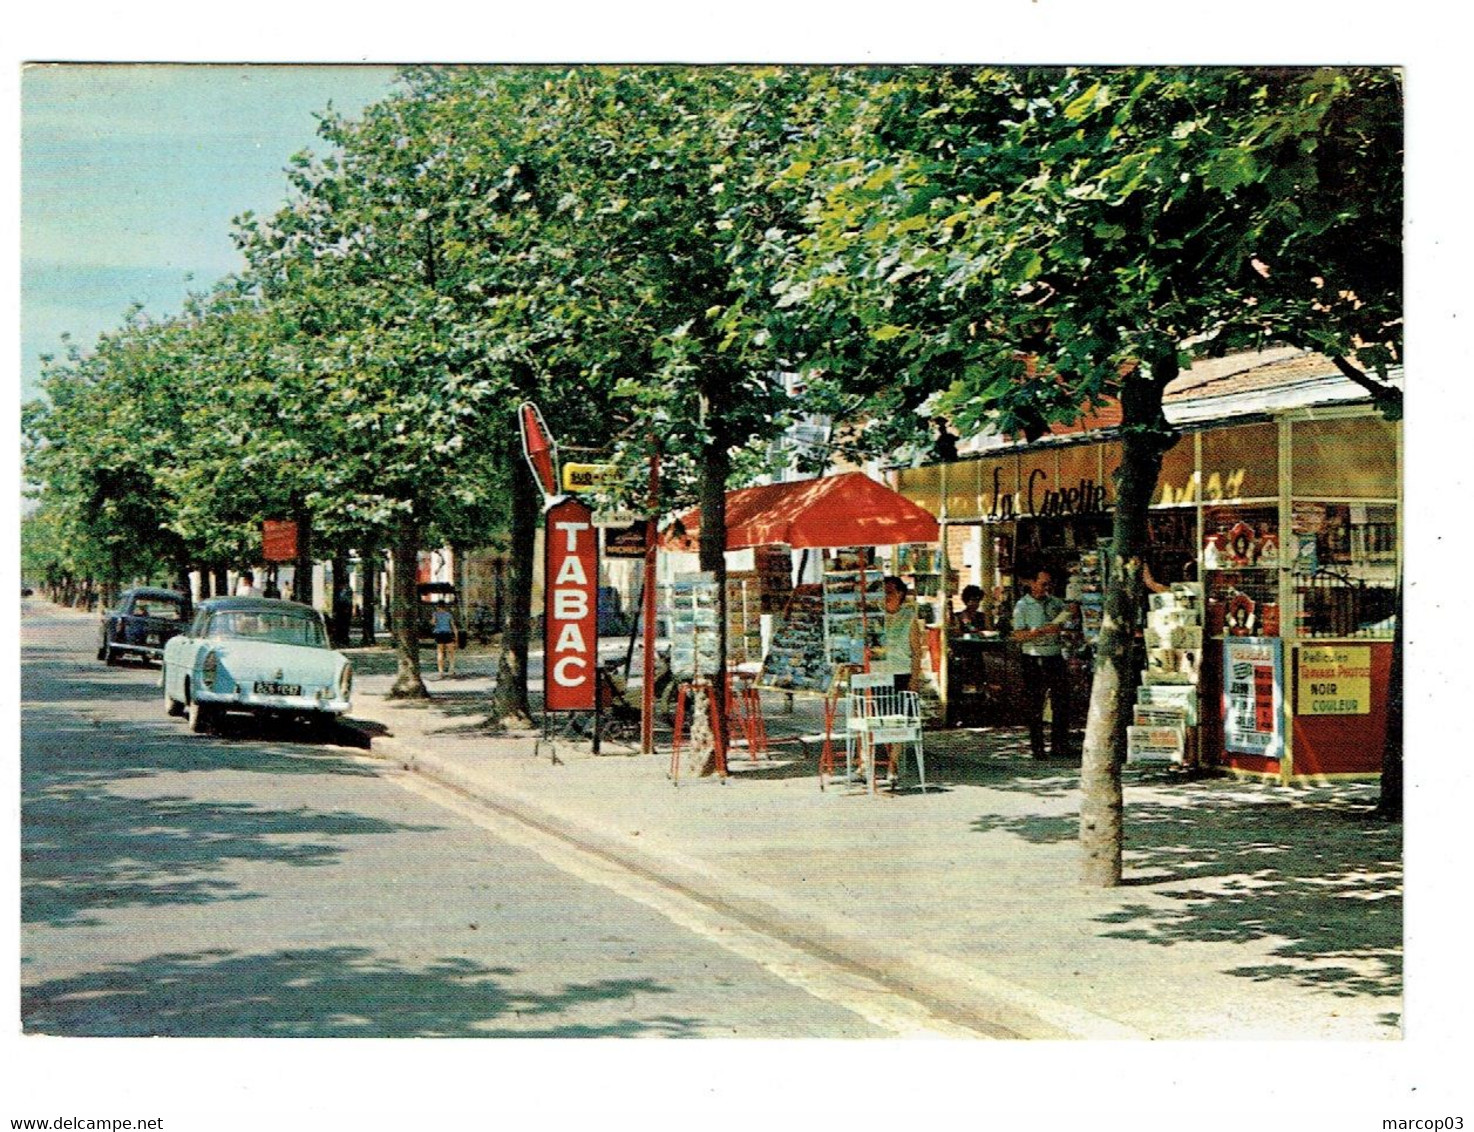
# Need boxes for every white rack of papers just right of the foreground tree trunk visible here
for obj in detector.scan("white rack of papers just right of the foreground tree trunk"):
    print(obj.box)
[1126,582,1203,765]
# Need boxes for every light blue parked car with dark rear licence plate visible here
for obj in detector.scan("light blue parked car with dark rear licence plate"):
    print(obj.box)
[162,597,354,733]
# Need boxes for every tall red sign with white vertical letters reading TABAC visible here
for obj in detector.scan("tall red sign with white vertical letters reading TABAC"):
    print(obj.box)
[542,498,598,712]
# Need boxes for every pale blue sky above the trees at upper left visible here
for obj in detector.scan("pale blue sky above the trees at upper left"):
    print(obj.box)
[21,65,394,398]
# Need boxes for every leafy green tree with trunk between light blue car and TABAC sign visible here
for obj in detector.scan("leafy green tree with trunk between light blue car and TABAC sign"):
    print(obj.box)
[232,84,527,696]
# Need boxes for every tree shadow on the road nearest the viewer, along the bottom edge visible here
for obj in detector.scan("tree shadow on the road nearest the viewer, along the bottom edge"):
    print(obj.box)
[21,946,699,1038]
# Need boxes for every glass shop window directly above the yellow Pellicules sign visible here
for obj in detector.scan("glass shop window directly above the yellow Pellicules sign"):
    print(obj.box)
[1288,500,1397,640]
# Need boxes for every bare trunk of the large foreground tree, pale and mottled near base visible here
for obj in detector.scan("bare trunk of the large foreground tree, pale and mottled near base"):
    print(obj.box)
[1080,346,1178,887]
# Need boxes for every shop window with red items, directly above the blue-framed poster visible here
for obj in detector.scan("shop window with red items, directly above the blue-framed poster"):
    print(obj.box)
[1203,504,1281,637]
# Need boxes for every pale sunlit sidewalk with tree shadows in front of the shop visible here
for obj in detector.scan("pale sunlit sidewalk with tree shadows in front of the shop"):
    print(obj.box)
[339,642,1402,1039]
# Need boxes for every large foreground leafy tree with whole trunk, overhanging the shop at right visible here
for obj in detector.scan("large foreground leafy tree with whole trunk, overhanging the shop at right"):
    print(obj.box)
[784,69,1400,884]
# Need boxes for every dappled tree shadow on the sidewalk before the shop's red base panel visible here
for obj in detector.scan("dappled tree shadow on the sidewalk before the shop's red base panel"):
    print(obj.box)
[973,783,1402,996]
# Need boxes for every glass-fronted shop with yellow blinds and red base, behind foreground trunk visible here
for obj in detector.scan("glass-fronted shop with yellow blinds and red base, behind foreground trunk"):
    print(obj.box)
[896,383,1402,781]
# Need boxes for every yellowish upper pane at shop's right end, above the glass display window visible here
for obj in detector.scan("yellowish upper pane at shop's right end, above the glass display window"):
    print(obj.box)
[1290,416,1397,500]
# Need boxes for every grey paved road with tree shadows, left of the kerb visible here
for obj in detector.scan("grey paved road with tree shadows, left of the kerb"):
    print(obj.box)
[21,601,945,1038]
